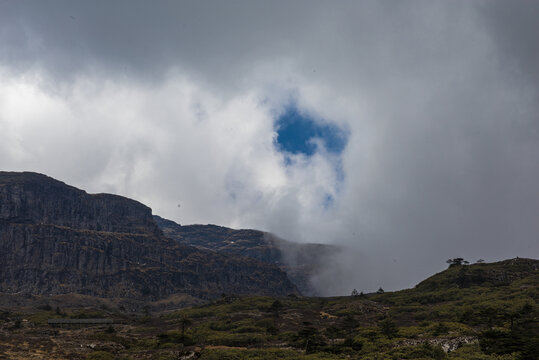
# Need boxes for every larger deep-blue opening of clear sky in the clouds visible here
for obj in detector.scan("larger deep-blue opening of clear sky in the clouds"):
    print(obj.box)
[275,106,348,156]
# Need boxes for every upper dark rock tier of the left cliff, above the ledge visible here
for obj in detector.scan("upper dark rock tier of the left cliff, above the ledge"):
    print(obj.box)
[0,172,159,234]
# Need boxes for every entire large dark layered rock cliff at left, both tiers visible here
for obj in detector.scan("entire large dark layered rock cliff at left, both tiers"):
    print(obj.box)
[0,172,297,299]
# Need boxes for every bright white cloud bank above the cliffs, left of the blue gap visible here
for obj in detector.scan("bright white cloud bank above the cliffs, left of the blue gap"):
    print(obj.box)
[0,68,337,236]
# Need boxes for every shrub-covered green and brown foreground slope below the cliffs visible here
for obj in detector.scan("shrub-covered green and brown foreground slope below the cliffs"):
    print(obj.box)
[0,259,539,360]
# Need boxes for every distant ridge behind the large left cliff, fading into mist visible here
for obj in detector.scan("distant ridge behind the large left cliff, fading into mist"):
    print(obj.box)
[154,215,340,296]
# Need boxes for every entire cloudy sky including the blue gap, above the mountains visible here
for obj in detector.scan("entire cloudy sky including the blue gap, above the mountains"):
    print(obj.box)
[0,0,539,295]
